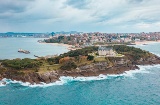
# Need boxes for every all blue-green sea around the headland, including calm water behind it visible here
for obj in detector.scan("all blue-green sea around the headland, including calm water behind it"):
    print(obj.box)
[0,38,160,105]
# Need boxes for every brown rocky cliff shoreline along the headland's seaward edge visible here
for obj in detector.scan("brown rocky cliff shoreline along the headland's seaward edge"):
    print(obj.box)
[0,56,160,84]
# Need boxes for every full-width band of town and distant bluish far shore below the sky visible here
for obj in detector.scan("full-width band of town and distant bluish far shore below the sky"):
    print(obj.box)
[0,31,160,47]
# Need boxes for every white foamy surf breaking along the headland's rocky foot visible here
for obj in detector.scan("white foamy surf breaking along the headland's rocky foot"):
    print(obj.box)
[0,64,160,88]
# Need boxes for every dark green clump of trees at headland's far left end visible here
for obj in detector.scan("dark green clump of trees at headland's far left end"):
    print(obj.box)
[2,58,42,70]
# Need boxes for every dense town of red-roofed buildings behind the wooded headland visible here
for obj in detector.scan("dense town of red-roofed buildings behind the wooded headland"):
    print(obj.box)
[51,32,160,47]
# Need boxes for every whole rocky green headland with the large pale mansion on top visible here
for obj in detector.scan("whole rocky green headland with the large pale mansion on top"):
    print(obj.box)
[0,45,160,84]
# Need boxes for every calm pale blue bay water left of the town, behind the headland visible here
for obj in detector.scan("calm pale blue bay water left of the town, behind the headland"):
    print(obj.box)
[0,38,68,59]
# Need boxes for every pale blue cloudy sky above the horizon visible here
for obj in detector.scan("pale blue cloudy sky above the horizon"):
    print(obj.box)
[0,0,160,33]
